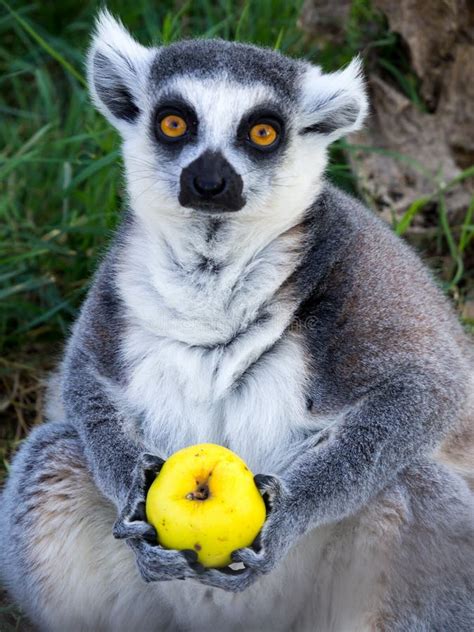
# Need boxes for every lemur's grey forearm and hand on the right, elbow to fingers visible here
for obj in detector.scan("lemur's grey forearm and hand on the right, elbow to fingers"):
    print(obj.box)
[193,356,462,591]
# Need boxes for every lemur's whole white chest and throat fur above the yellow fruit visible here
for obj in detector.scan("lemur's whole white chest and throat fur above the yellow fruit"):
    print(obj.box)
[118,216,314,472]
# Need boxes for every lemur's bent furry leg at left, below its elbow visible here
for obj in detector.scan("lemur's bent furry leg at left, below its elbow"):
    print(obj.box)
[0,424,176,632]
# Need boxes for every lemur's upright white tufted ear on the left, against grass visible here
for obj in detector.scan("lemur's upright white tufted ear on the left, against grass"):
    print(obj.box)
[87,11,153,131]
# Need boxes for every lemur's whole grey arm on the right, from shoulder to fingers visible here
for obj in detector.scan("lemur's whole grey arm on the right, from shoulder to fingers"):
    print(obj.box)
[193,225,467,591]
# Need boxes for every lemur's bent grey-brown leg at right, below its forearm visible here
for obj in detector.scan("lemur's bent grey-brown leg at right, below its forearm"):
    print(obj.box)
[294,461,474,632]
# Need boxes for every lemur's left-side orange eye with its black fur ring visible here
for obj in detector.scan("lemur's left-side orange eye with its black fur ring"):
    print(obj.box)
[153,103,198,145]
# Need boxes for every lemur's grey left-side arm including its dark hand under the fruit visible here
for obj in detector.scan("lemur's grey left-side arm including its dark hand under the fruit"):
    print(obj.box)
[62,264,206,581]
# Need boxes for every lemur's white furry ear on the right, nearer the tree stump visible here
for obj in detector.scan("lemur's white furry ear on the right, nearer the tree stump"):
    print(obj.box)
[299,57,368,142]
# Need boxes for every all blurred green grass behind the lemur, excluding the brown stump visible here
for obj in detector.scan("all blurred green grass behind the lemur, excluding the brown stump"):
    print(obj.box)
[0,0,474,630]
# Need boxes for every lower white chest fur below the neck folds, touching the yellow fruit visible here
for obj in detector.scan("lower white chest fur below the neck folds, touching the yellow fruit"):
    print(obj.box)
[122,324,306,472]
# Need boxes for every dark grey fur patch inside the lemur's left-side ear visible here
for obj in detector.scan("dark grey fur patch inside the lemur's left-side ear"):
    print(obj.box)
[93,52,140,123]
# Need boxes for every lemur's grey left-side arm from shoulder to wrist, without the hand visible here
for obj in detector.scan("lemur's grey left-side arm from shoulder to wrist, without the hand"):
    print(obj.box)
[62,260,143,508]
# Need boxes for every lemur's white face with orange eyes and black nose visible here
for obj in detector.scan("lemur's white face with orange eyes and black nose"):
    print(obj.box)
[143,75,286,213]
